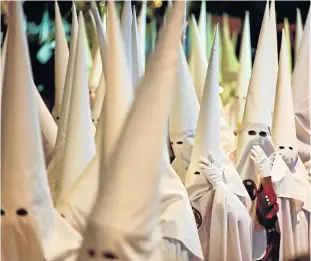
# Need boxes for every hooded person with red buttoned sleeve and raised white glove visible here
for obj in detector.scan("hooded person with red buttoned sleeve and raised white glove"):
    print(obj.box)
[236,2,279,260]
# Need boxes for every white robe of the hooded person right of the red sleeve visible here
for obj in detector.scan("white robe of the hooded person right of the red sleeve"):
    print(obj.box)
[272,154,310,261]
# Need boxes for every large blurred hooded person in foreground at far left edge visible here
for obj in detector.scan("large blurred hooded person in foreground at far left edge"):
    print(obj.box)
[1,2,81,261]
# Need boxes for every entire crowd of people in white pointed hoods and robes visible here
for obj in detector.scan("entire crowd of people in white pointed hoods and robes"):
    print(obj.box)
[1,1,311,261]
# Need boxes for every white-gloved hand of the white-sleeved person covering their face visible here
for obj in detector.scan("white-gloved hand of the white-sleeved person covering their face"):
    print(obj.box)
[198,154,224,187]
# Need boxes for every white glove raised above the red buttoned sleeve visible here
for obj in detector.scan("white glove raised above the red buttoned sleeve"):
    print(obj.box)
[250,145,271,178]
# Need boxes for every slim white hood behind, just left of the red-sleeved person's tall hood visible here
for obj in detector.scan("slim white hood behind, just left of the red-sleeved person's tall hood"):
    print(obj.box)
[235,11,252,126]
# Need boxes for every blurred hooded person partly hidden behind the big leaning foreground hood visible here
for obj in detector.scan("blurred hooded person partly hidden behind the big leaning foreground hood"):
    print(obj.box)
[57,2,133,234]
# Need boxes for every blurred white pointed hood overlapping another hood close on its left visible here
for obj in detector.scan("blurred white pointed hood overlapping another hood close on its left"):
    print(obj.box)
[58,13,95,201]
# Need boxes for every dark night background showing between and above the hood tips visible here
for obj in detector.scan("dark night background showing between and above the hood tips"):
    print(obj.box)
[1,1,310,109]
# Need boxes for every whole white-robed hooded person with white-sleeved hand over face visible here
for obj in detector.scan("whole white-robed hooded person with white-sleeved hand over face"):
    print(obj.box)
[186,27,251,261]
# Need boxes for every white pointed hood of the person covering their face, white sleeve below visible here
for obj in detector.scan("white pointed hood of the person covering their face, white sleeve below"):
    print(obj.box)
[186,26,248,198]
